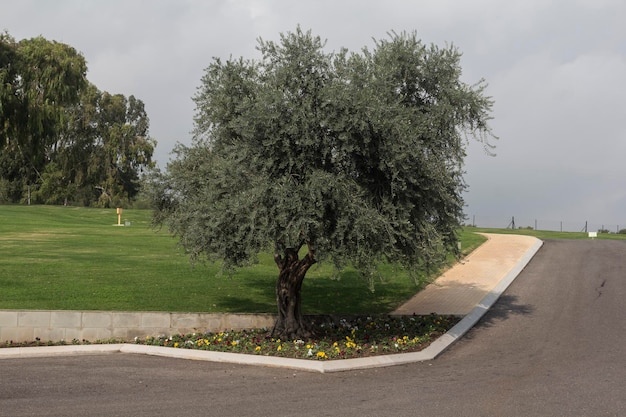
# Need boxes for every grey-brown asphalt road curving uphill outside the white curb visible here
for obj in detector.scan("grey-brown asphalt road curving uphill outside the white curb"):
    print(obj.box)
[0,240,626,417]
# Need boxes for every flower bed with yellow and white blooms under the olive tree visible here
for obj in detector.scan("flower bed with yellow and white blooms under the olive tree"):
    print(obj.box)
[135,315,460,360]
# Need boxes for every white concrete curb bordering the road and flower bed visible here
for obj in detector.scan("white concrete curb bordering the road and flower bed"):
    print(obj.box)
[0,239,543,373]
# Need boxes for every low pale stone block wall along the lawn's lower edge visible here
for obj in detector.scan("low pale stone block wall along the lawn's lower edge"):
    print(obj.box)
[0,310,276,342]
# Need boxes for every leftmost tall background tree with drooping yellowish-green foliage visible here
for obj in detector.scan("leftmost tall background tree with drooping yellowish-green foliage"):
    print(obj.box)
[0,33,87,198]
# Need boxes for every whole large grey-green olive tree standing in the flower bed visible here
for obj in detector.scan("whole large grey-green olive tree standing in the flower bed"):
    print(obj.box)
[156,28,492,338]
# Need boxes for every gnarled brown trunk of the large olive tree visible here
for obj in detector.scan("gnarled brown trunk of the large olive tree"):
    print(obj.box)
[272,248,315,340]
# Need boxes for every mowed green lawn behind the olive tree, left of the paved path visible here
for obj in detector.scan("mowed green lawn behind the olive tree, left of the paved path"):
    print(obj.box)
[0,205,484,314]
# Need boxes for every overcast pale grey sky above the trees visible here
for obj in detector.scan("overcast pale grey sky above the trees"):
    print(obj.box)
[0,0,626,231]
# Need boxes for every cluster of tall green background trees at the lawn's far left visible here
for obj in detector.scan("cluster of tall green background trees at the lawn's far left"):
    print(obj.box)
[0,32,156,207]
